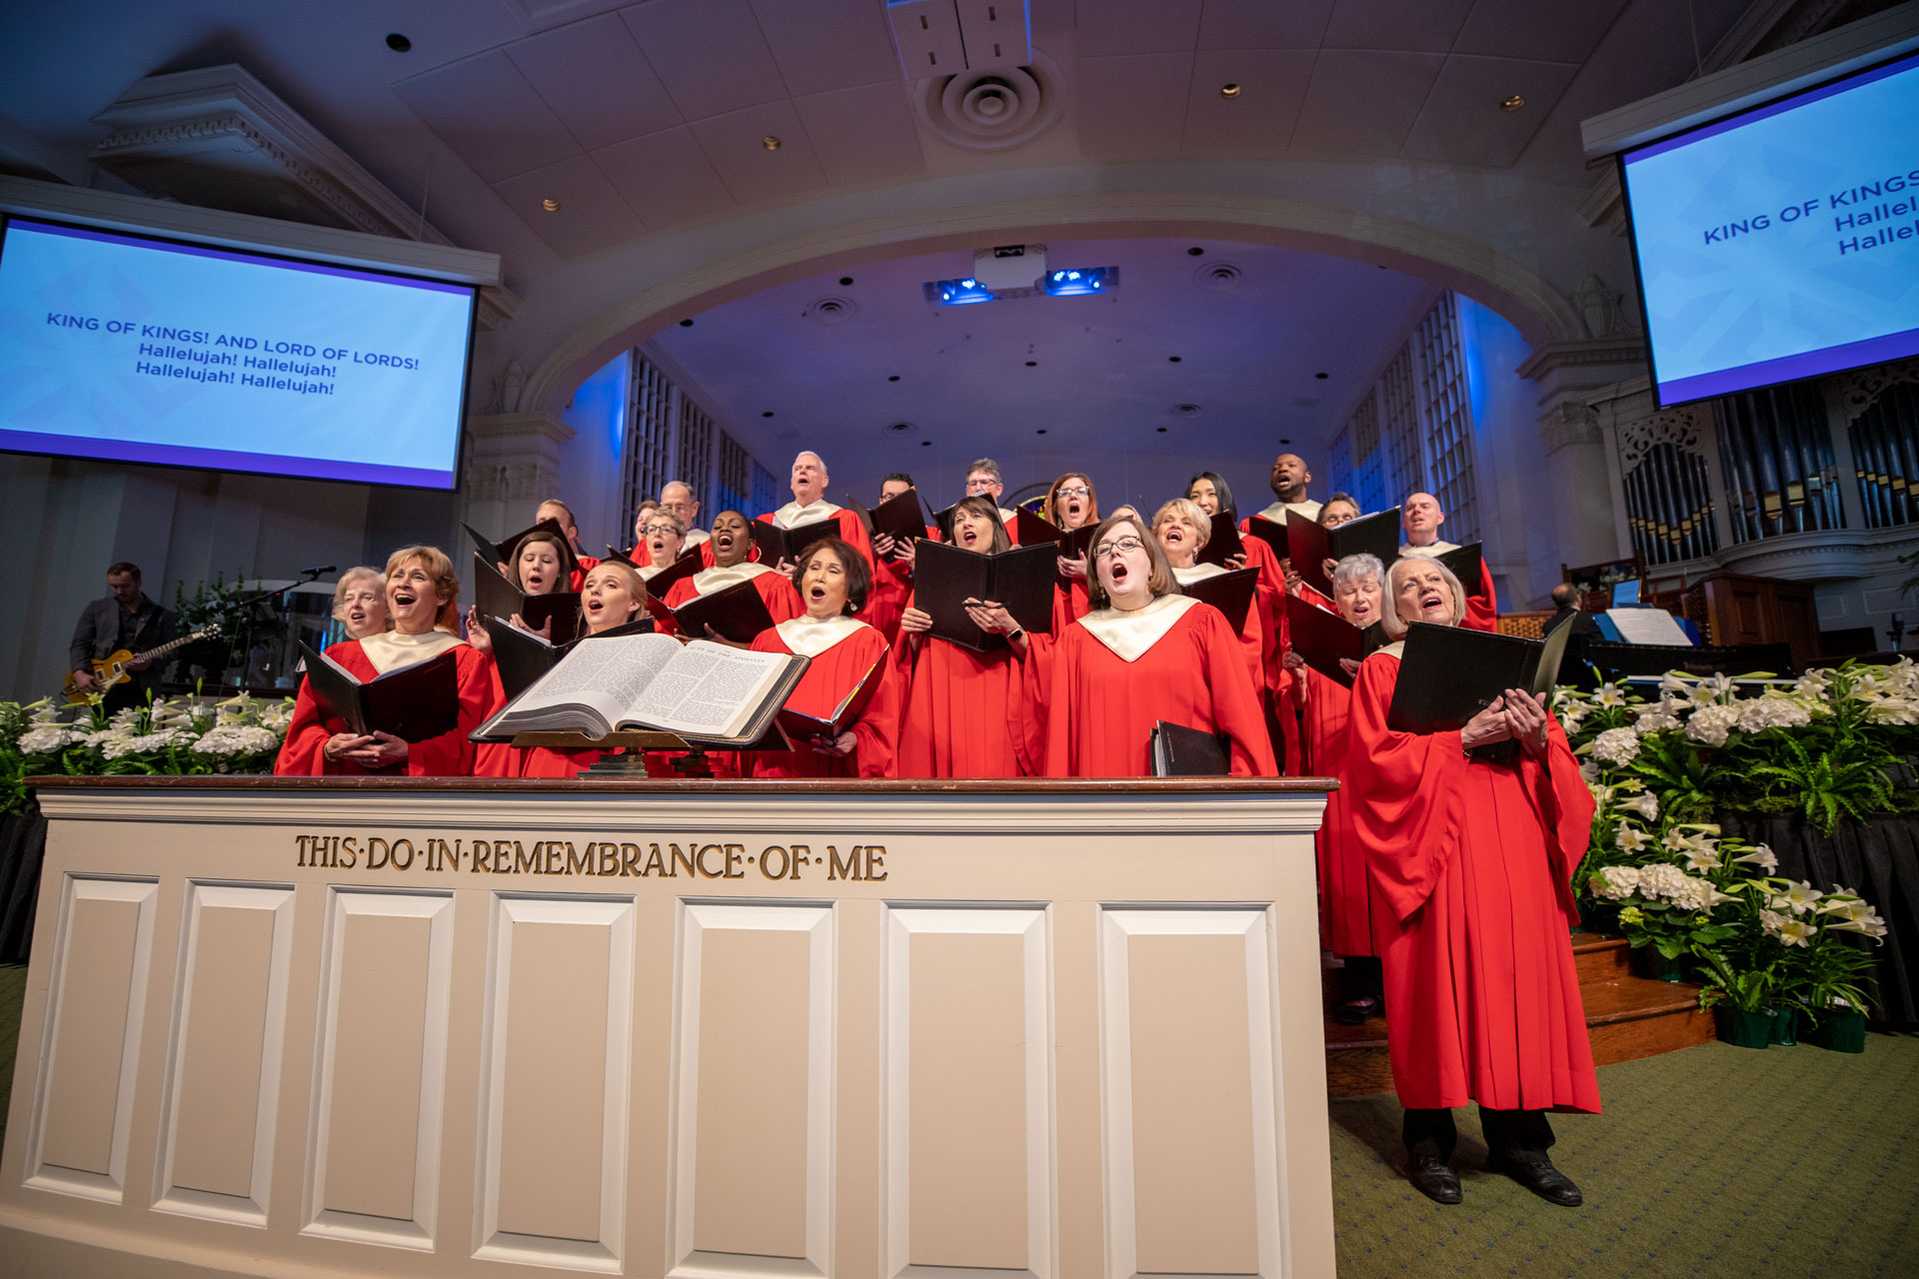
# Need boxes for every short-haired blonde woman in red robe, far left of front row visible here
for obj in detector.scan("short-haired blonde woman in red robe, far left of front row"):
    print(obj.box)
[272,545,493,778]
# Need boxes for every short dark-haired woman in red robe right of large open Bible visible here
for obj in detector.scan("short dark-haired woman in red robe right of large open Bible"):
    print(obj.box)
[741,538,900,778]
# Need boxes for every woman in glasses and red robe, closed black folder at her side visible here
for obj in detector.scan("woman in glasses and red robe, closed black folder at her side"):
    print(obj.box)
[1032,513,1276,778]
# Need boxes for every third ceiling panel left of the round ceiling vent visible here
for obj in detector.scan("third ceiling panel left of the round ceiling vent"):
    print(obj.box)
[507,13,681,152]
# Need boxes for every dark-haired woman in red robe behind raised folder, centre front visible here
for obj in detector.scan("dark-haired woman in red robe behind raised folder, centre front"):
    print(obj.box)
[898,494,1040,778]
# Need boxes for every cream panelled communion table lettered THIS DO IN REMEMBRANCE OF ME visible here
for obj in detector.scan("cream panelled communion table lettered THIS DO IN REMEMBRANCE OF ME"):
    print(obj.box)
[0,778,1334,1279]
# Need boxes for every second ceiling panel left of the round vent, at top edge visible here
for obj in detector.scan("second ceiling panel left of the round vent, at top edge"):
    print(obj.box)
[620,0,787,119]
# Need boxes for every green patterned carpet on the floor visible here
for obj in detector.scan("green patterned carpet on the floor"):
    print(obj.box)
[0,966,1919,1279]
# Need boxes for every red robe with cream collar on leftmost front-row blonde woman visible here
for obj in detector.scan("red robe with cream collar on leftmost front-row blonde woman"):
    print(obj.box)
[272,630,499,778]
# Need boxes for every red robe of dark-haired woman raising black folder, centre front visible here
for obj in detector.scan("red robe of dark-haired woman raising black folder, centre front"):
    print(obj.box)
[896,601,1042,778]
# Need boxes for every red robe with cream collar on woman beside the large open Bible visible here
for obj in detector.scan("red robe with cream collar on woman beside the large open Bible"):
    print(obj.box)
[741,616,900,778]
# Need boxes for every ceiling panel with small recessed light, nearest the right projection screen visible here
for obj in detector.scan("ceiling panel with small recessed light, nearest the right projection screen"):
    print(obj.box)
[1407,54,1577,169]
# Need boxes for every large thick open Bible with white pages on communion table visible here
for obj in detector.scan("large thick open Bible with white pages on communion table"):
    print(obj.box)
[474,636,806,745]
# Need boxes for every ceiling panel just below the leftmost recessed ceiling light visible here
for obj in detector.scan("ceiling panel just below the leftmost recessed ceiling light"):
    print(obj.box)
[393,50,580,182]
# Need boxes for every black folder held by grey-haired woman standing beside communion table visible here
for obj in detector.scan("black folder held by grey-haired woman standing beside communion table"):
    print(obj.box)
[1386,622,1572,734]
